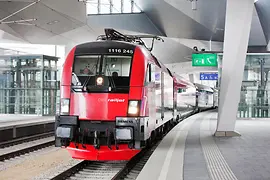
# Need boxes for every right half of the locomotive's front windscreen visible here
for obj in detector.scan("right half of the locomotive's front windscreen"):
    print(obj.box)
[103,56,132,77]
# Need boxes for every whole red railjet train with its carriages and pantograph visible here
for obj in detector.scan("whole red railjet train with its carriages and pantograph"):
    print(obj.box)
[55,29,217,161]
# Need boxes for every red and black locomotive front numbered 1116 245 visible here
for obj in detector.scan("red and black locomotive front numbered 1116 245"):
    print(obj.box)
[55,41,147,160]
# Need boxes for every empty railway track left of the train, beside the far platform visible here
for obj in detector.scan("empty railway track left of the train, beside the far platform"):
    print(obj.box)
[0,133,54,161]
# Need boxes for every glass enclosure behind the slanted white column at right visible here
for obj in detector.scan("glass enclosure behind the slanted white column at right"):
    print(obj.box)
[219,53,270,118]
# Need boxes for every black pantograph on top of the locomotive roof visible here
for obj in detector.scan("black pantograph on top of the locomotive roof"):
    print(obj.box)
[97,28,164,51]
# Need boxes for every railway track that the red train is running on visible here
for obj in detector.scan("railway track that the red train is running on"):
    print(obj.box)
[51,111,202,180]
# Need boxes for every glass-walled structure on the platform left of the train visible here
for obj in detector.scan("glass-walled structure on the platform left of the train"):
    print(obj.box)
[0,55,59,115]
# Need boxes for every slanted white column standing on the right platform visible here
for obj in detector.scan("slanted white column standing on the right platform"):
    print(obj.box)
[215,0,254,136]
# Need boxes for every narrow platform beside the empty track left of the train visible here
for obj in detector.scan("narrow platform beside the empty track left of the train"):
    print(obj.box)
[0,114,55,142]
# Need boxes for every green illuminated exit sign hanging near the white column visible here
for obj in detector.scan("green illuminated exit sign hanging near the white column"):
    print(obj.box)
[192,54,217,66]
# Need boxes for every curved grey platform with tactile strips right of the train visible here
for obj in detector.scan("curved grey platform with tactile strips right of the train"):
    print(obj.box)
[137,111,270,180]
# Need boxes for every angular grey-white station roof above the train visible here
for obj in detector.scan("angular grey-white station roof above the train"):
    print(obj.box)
[0,0,270,64]
